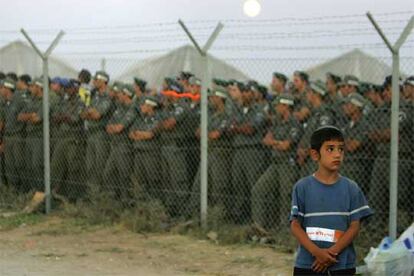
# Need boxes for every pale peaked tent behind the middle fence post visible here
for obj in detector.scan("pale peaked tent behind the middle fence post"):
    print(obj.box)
[117,45,248,87]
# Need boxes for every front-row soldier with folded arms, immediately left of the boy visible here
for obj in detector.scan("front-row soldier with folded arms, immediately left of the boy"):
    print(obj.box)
[252,93,301,229]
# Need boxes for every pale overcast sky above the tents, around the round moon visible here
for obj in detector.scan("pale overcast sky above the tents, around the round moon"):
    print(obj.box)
[0,0,414,81]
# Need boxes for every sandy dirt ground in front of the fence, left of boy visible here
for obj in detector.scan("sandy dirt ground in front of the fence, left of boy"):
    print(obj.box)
[0,217,293,276]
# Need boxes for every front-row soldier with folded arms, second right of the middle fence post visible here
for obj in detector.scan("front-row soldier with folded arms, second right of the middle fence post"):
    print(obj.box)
[229,83,266,223]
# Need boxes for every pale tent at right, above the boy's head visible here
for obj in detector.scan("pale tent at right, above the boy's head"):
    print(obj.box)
[305,49,392,84]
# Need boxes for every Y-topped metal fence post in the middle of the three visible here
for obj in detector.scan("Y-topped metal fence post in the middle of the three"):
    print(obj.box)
[178,20,223,229]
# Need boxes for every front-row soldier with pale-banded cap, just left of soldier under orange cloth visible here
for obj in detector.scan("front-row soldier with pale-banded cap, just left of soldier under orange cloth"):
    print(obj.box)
[128,96,163,200]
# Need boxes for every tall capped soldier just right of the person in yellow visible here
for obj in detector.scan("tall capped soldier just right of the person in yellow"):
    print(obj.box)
[81,71,112,188]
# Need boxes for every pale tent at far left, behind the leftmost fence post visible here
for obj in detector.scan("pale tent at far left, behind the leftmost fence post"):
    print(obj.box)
[0,41,77,78]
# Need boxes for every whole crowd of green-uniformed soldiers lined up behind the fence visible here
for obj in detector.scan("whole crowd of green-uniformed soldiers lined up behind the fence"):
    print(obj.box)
[0,70,414,228]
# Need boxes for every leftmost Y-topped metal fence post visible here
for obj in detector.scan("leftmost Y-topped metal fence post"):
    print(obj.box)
[20,29,64,214]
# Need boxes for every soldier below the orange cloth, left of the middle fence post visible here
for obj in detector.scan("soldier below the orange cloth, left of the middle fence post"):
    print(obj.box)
[160,81,190,217]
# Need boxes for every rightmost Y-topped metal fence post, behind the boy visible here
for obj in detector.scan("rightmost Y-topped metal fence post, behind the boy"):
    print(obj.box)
[367,12,414,240]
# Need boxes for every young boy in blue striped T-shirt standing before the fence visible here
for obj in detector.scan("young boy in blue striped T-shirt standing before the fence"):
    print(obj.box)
[290,126,373,275]
